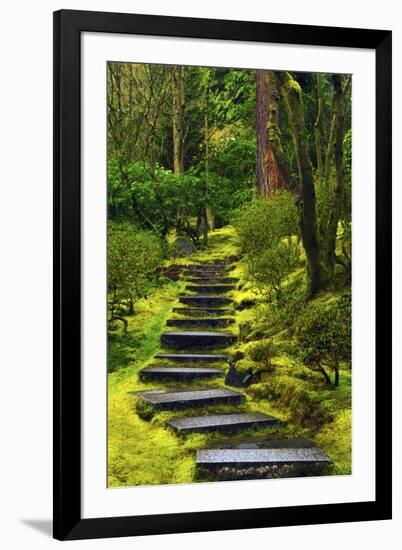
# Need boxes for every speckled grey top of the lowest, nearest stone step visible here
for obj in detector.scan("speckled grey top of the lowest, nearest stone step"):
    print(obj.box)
[196,447,331,468]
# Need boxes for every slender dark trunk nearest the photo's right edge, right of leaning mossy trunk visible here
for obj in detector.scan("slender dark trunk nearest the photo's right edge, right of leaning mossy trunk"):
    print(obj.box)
[325,74,345,278]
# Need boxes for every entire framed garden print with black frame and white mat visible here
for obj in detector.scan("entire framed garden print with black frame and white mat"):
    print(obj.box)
[54,10,391,540]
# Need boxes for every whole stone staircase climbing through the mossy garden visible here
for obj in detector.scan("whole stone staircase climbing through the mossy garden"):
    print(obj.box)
[138,261,330,480]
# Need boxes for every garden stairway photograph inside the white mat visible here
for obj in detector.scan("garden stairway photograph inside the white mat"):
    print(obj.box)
[107,61,353,489]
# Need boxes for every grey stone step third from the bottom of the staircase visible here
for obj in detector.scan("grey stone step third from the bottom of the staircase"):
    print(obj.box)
[139,388,244,410]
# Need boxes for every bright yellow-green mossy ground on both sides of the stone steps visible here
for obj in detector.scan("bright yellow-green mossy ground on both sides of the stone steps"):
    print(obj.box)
[108,227,351,487]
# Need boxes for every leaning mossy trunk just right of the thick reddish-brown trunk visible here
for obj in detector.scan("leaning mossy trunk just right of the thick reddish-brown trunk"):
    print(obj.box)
[276,72,325,298]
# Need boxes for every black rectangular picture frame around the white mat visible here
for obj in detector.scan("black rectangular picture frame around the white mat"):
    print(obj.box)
[53,10,392,540]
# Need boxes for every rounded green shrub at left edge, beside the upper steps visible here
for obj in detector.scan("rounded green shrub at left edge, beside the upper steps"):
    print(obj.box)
[108,222,163,321]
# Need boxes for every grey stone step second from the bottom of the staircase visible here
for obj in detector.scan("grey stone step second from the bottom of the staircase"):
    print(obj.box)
[167,413,279,434]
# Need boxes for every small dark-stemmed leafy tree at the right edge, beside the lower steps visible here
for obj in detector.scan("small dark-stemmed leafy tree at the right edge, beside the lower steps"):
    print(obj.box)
[295,294,351,386]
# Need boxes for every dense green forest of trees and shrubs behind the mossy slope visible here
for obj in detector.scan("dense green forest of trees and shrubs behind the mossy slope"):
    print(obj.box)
[108,63,351,312]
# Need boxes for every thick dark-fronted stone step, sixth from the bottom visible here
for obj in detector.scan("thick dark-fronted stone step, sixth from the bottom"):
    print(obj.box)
[161,331,235,349]
